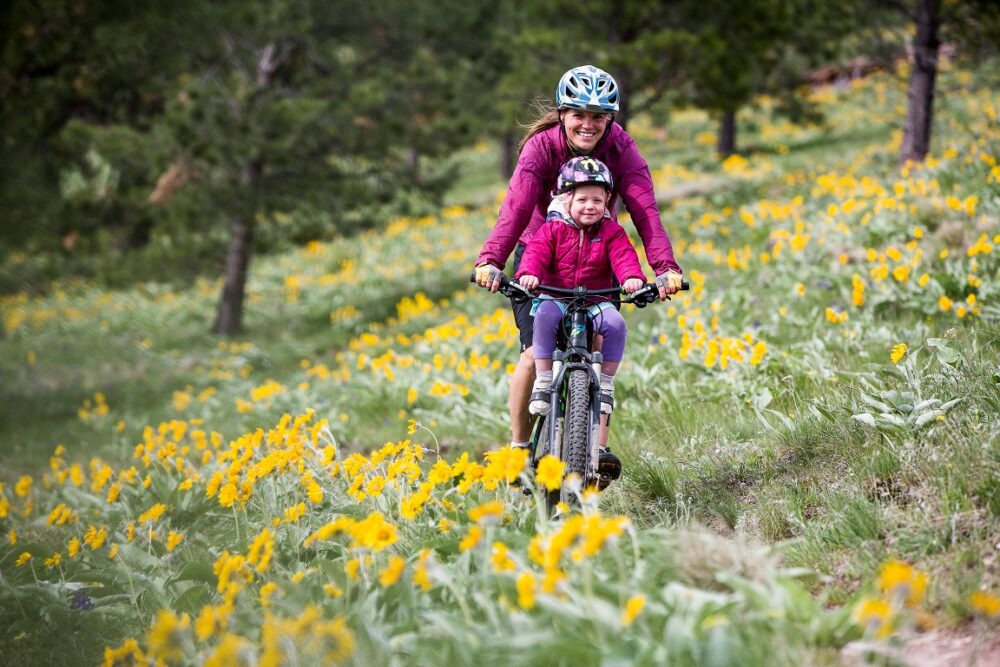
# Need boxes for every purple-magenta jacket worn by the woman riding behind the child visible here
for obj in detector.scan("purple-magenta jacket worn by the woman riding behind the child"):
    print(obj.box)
[476,123,681,275]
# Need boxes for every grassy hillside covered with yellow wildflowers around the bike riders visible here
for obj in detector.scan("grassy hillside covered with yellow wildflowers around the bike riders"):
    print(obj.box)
[0,60,1000,665]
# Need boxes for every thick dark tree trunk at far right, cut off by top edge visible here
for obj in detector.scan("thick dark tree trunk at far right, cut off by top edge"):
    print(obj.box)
[899,0,941,165]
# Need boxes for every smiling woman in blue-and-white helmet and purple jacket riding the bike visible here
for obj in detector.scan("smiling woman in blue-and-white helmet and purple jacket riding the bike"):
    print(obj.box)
[476,65,682,479]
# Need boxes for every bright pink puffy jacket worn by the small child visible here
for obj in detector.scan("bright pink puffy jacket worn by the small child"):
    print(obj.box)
[514,214,646,289]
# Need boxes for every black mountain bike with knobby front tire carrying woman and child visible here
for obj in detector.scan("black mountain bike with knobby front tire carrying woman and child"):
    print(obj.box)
[476,276,689,511]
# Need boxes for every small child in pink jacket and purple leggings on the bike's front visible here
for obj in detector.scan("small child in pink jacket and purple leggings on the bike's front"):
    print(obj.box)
[515,157,646,479]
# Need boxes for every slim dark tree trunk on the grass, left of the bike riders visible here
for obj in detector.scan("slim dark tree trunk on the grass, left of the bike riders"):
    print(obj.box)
[212,163,261,336]
